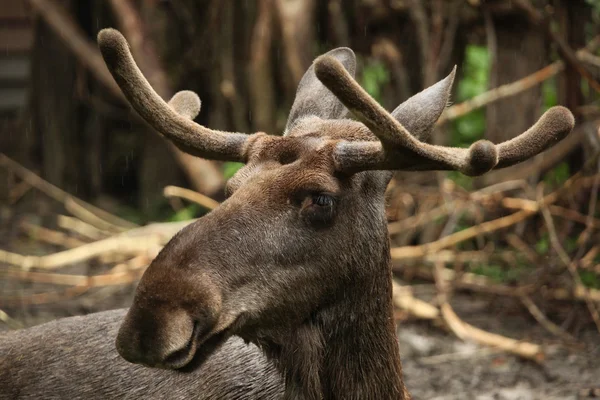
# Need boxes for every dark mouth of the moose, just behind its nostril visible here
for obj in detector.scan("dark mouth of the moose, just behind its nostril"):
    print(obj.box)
[163,322,231,372]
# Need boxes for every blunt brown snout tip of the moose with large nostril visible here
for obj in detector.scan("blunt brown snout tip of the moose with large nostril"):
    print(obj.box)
[116,306,212,369]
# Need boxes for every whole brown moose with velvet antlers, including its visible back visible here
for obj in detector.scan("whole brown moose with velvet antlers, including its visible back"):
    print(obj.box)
[0,29,575,399]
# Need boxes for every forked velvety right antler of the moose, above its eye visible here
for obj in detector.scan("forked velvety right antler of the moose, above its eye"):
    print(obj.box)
[315,56,575,176]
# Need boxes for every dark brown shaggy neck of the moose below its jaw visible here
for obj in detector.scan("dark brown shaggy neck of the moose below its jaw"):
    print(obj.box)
[258,195,410,400]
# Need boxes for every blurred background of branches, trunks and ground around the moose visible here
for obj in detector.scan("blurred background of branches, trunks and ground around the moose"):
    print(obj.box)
[0,0,600,399]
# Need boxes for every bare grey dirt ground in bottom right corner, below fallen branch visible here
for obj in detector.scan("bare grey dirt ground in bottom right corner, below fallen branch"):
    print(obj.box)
[399,324,600,400]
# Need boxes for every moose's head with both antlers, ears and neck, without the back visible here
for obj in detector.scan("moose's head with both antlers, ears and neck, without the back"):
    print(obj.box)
[98,29,574,398]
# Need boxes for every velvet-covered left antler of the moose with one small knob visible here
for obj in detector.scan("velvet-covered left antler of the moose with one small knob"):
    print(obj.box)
[98,28,249,162]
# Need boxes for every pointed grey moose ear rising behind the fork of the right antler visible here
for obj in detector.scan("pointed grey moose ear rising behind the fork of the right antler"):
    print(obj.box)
[392,66,456,142]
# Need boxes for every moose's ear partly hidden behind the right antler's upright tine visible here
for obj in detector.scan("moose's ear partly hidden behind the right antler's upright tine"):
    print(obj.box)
[285,47,356,134]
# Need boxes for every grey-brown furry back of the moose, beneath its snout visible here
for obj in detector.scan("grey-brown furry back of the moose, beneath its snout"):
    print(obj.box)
[0,310,283,400]
